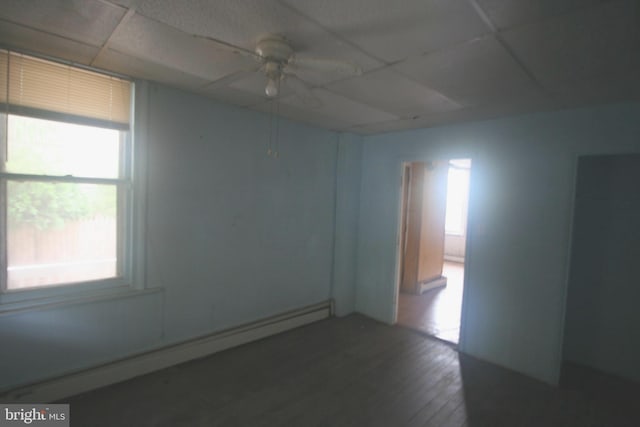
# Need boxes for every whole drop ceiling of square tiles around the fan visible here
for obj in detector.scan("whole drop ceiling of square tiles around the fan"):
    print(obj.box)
[0,0,640,134]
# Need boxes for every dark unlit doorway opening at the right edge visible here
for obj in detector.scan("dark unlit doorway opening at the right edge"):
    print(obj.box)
[563,154,640,381]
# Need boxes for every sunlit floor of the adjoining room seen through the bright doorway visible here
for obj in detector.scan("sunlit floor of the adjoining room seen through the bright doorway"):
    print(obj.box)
[398,261,464,344]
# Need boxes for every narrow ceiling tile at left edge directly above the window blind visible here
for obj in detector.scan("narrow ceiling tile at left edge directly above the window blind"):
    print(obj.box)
[0,20,100,65]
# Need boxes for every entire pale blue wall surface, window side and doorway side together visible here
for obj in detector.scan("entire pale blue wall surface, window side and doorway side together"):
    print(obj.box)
[5,77,640,390]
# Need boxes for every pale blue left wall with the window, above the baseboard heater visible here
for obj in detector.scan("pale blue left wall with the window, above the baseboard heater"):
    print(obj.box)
[0,84,350,390]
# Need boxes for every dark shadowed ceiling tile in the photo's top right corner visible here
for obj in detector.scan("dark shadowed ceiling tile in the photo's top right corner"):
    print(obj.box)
[503,0,640,90]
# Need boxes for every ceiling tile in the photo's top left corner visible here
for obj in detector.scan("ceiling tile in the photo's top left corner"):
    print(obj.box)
[0,0,126,46]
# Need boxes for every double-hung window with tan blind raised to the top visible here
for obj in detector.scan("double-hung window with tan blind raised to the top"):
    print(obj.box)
[0,50,132,293]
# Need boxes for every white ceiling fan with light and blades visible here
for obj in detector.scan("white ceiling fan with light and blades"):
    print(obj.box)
[200,34,362,107]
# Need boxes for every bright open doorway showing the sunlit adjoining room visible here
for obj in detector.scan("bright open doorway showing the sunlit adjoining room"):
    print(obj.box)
[397,159,471,344]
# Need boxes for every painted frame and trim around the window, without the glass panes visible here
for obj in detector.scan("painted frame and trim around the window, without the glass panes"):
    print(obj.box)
[0,50,148,314]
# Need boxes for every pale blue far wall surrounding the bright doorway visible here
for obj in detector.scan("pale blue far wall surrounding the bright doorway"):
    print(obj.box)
[356,105,640,383]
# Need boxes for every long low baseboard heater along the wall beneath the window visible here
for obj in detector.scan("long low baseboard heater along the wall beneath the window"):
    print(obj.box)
[0,301,333,403]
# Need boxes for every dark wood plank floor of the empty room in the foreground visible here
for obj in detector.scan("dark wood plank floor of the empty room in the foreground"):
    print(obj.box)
[66,315,640,427]
